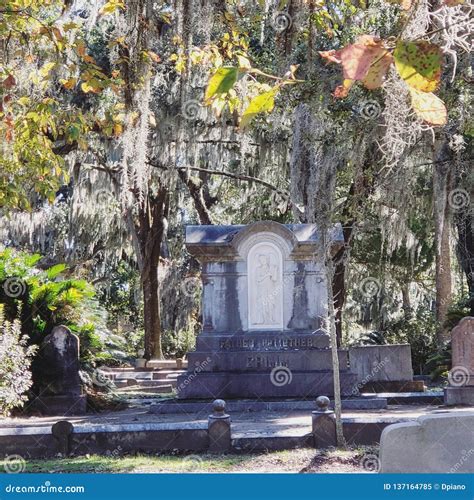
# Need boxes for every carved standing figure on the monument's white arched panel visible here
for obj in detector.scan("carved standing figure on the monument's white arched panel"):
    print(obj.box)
[255,253,278,325]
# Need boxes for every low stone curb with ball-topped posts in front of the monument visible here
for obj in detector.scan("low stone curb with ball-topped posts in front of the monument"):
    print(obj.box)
[0,396,430,459]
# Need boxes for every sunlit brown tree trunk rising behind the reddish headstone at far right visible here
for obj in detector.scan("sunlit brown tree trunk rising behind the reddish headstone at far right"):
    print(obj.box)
[433,142,452,346]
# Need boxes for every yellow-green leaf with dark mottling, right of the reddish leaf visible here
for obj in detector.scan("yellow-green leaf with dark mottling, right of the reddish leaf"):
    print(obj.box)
[393,41,441,92]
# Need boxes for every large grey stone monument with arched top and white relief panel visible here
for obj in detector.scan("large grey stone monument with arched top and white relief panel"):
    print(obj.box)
[177,222,357,399]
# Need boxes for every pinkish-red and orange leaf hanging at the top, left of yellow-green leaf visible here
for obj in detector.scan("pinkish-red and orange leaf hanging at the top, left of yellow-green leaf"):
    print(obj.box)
[319,35,393,97]
